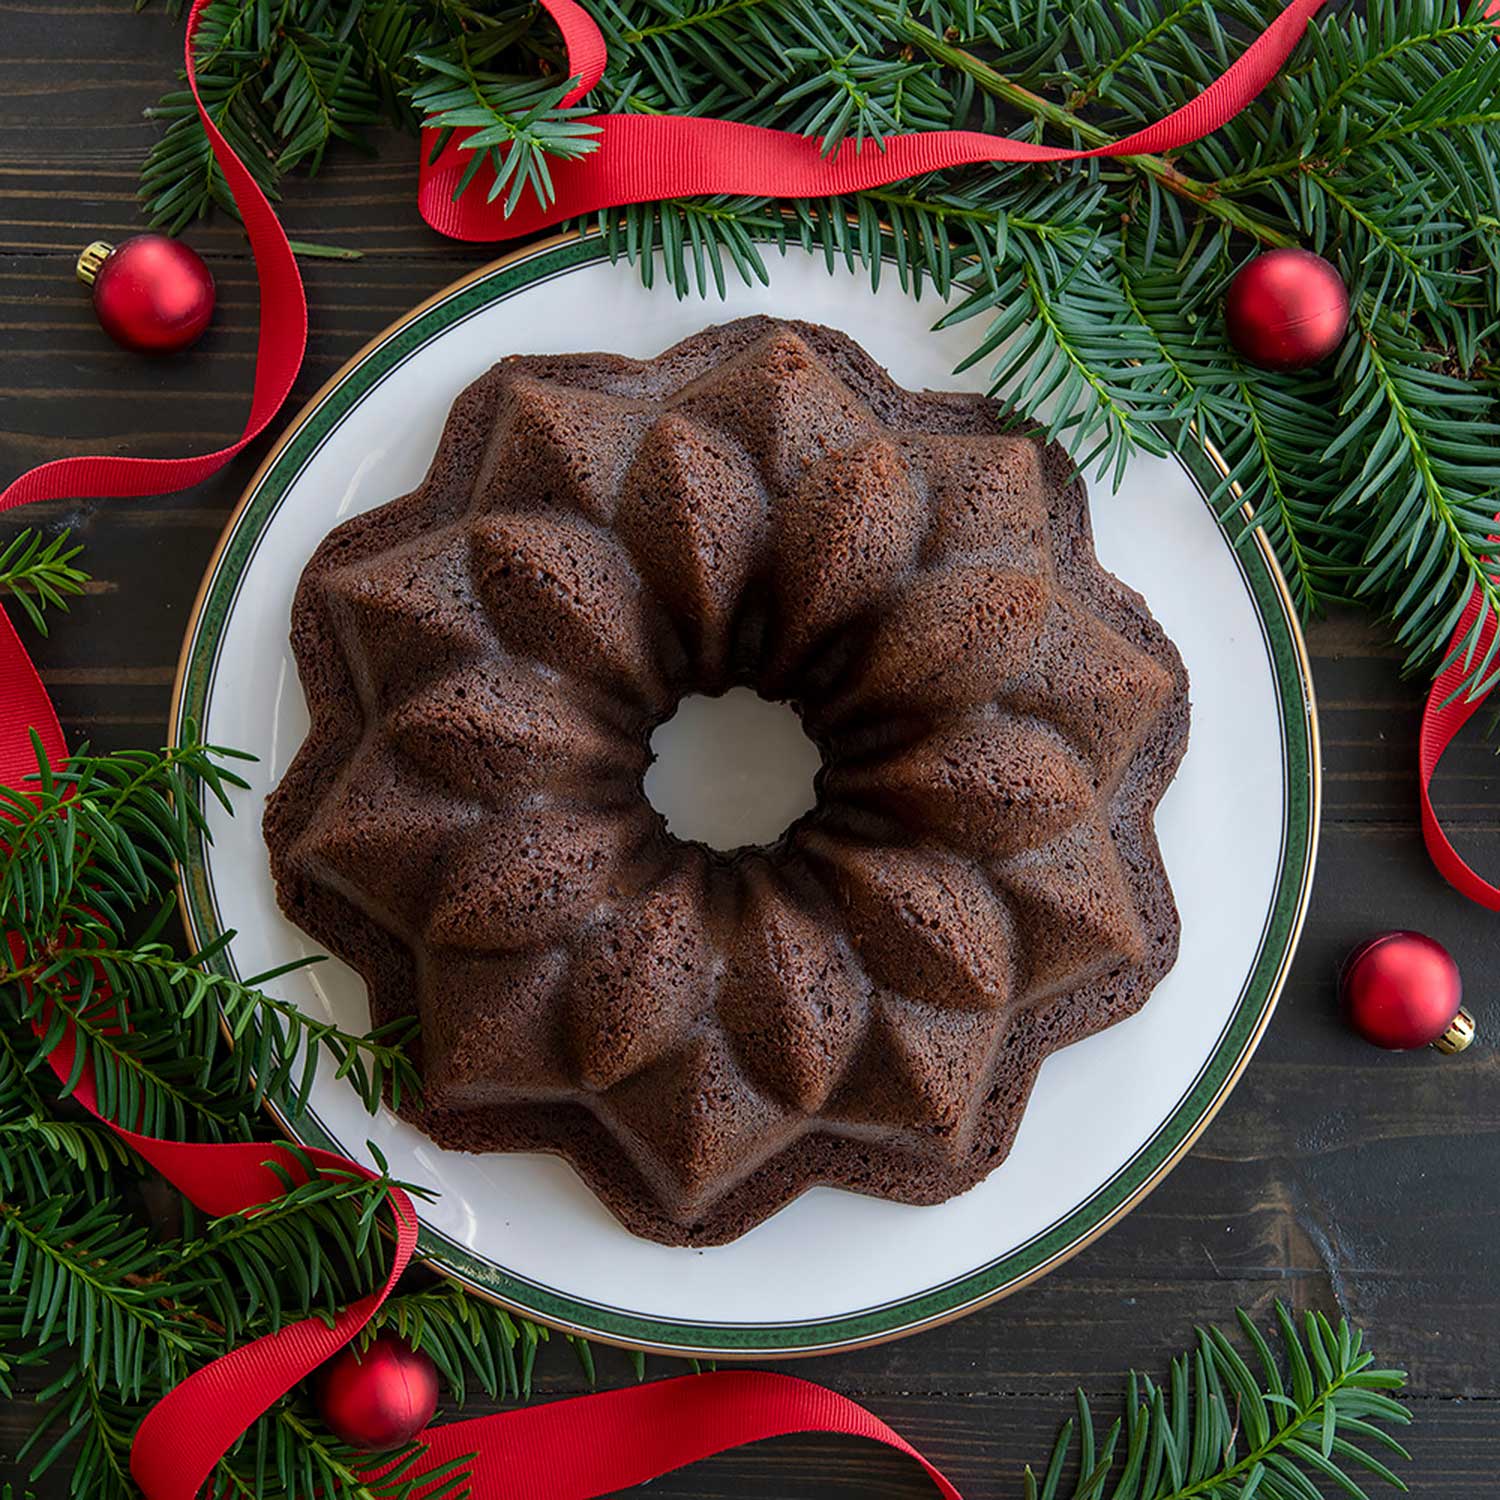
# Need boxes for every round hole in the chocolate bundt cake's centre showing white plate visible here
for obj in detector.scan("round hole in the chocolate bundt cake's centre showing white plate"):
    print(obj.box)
[645,687,822,849]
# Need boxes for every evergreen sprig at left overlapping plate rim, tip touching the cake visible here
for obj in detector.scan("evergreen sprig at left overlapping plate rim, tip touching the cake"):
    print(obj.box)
[0,726,419,1134]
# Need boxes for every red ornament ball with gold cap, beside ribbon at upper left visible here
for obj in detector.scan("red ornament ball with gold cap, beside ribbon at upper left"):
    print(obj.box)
[78,234,213,354]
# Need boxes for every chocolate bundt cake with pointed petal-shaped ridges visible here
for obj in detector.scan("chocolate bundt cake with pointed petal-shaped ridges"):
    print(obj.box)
[266,318,1188,1245]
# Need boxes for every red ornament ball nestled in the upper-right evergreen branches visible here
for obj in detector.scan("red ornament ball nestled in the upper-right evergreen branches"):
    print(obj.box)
[1224,249,1349,371]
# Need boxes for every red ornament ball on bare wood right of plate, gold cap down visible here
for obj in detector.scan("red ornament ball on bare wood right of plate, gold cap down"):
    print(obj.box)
[1338,932,1475,1053]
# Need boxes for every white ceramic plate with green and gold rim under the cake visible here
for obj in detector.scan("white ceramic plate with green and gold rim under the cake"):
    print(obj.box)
[174,237,1317,1358]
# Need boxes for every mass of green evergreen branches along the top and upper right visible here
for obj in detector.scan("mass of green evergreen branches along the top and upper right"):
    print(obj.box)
[143,0,1500,708]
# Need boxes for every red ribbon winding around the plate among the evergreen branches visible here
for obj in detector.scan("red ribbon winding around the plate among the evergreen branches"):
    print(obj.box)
[0,0,1476,1500]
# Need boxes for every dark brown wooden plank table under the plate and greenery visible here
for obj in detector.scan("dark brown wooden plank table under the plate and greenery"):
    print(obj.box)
[0,0,1500,1500]
